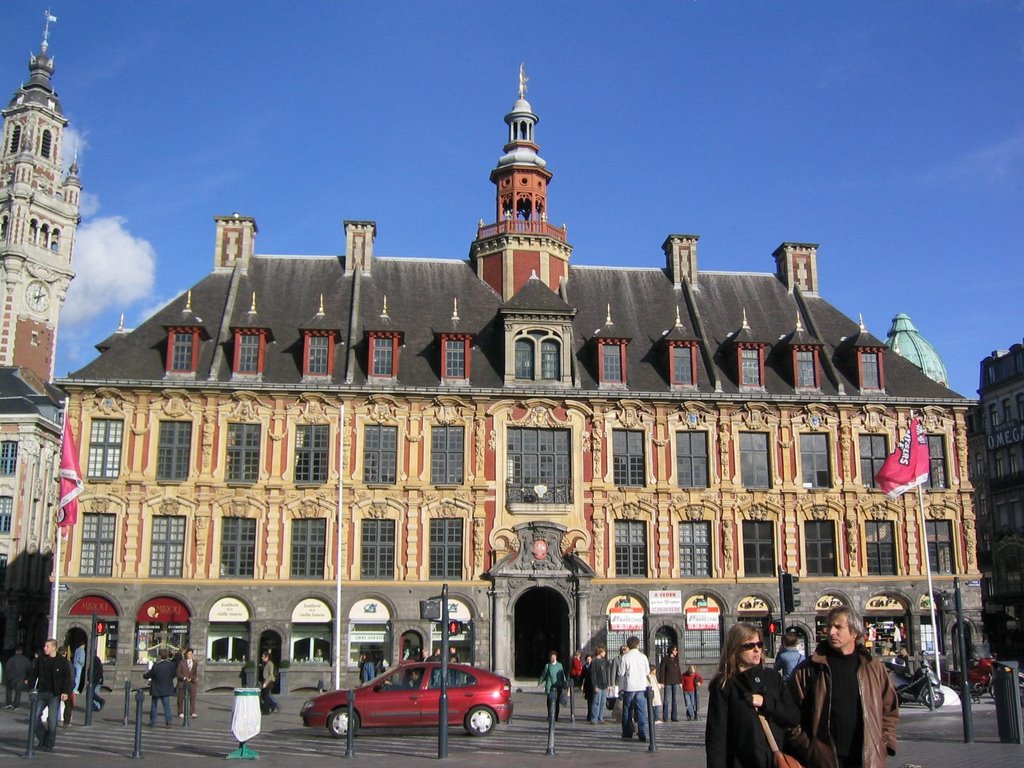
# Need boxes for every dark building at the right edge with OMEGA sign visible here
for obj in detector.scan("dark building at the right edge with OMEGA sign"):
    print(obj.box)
[969,344,1024,658]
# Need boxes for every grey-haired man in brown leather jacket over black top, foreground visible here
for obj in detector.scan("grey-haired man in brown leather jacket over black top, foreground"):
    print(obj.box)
[790,605,899,768]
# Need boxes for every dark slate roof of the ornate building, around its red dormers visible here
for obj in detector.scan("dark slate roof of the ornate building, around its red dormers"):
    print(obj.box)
[66,250,961,400]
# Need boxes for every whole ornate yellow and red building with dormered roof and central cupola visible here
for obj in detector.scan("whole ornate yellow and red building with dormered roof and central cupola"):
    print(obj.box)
[59,79,980,689]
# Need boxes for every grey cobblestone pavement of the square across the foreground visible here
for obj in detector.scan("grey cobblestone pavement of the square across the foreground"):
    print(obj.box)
[0,687,1024,768]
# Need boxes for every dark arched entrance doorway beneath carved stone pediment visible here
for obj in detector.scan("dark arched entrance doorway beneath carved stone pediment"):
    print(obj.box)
[513,587,572,680]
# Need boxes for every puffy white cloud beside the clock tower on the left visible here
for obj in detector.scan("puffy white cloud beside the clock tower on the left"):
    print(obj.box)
[60,216,157,326]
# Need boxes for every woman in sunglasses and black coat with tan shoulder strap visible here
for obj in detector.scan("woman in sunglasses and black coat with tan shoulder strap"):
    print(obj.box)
[705,623,800,768]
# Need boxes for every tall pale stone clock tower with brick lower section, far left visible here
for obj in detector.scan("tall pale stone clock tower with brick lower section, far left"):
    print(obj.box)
[0,23,82,381]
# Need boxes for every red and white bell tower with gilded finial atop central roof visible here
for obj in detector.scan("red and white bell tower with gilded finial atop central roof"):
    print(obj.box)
[470,66,572,301]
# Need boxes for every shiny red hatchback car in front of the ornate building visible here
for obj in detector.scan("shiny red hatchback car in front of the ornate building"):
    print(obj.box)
[301,662,512,738]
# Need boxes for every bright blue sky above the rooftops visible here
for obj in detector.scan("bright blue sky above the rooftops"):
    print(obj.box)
[0,0,1024,396]
